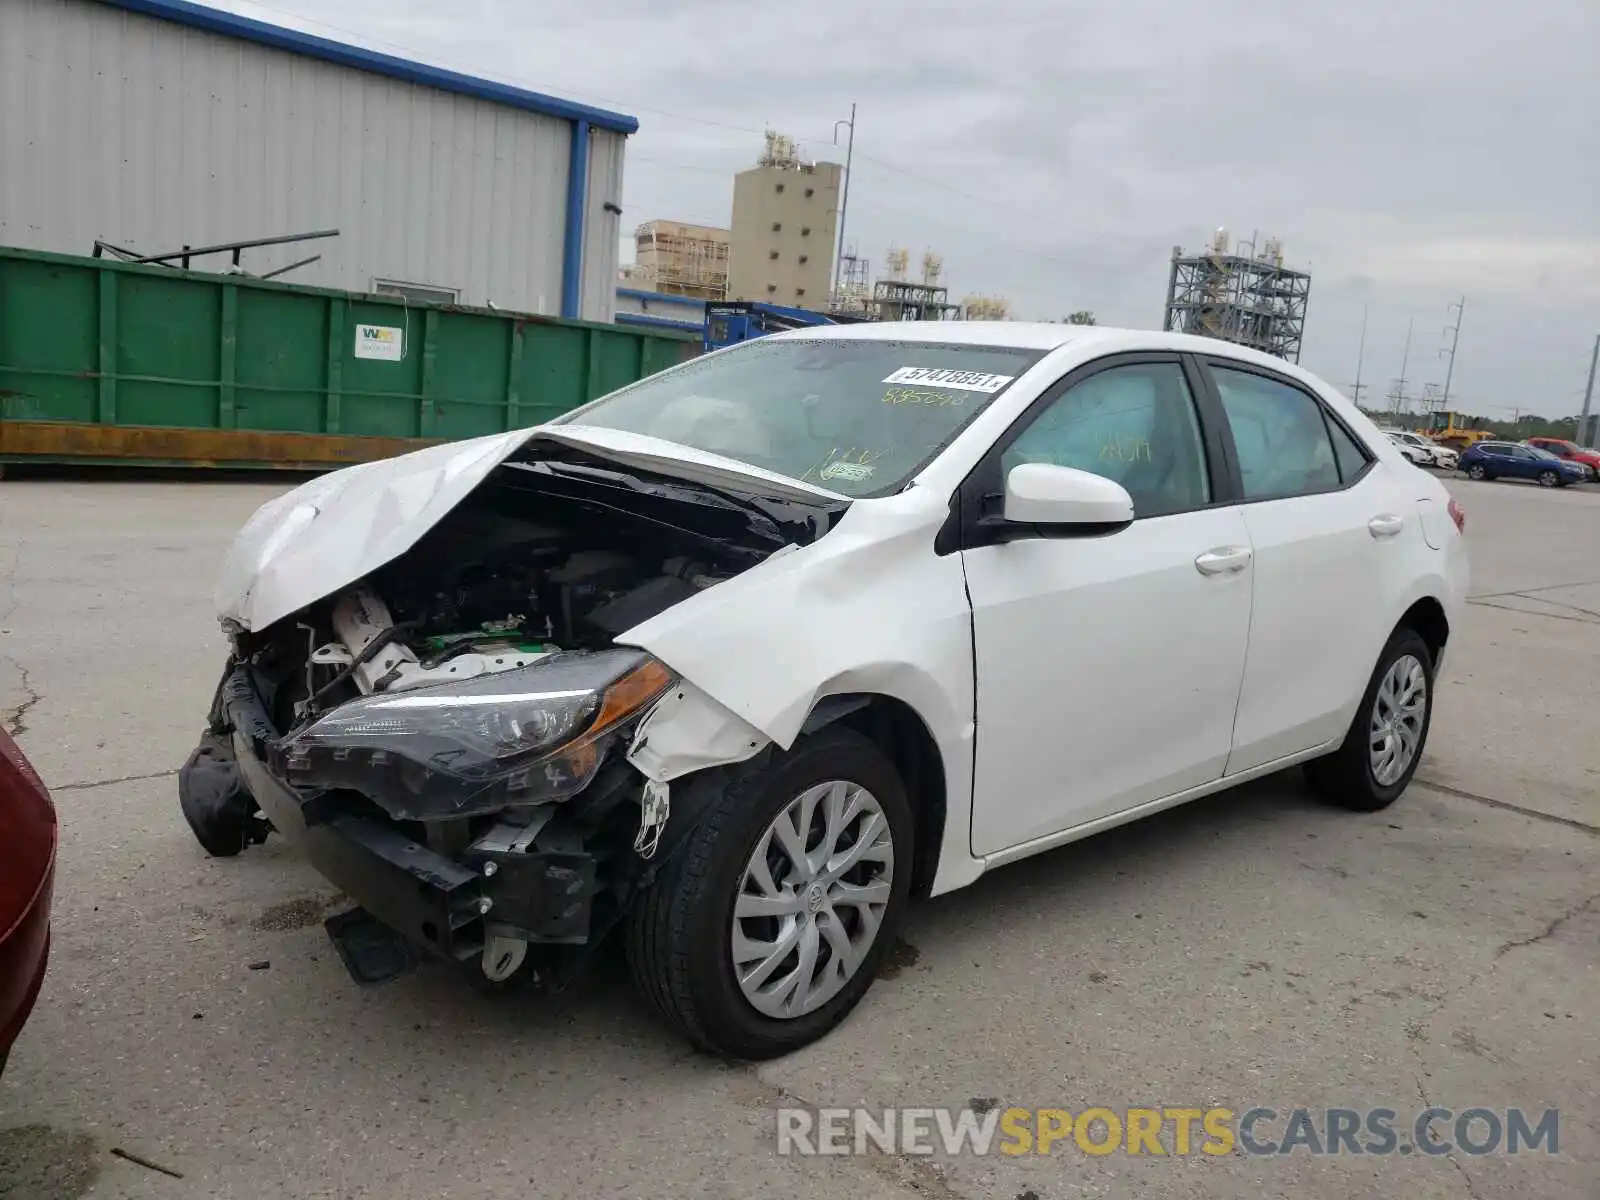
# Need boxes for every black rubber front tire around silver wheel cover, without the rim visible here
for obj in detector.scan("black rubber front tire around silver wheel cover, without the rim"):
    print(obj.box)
[627,726,914,1061]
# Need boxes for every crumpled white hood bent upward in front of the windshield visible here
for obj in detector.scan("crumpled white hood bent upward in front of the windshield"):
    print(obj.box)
[213,424,843,629]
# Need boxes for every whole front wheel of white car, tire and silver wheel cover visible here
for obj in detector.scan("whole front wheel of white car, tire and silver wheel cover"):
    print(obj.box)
[627,728,912,1059]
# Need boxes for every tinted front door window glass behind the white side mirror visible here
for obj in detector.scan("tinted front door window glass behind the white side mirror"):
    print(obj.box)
[1000,363,1211,517]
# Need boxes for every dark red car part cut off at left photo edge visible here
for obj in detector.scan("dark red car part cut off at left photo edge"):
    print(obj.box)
[0,730,56,1070]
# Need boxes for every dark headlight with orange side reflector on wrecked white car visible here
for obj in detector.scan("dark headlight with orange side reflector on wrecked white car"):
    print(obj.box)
[272,650,674,821]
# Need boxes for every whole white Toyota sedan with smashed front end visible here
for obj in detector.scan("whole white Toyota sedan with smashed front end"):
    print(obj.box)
[179,322,1467,1058]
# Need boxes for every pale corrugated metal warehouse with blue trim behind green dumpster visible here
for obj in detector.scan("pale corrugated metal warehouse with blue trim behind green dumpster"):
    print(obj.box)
[0,0,638,322]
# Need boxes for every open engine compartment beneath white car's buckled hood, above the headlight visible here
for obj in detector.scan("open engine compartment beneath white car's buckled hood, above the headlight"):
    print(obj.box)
[254,451,830,725]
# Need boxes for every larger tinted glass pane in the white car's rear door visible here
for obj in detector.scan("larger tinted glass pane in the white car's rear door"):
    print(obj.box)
[1211,363,1354,501]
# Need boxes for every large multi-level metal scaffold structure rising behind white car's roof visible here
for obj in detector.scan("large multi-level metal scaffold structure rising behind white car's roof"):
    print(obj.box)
[1162,229,1310,363]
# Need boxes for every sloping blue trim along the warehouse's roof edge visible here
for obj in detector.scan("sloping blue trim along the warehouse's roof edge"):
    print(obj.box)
[99,0,638,133]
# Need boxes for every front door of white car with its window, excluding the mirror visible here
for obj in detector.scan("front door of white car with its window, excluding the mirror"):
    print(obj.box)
[963,355,1251,854]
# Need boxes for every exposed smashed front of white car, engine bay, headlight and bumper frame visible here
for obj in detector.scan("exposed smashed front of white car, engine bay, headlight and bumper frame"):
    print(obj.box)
[179,443,843,981]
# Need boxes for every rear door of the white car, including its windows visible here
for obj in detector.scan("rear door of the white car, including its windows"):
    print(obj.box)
[1205,357,1422,774]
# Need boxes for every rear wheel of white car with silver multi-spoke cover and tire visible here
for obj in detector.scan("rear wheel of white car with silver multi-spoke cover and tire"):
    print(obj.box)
[1306,627,1434,813]
